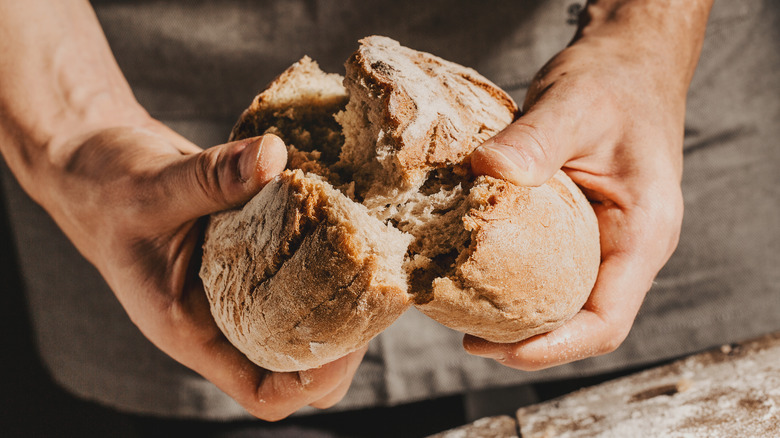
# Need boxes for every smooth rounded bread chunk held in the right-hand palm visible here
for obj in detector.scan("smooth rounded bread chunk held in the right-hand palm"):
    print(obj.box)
[416,171,600,342]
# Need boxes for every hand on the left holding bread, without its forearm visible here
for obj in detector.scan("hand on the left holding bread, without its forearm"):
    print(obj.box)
[42,120,365,420]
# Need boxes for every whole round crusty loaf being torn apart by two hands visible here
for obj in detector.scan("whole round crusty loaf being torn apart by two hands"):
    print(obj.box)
[201,36,600,371]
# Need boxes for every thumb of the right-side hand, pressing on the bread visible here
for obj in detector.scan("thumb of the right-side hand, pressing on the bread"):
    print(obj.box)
[471,110,571,186]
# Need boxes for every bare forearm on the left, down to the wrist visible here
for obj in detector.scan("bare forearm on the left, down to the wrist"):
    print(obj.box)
[0,0,147,202]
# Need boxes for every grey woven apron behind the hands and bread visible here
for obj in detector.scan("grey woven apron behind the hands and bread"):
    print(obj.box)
[2,0,780,419]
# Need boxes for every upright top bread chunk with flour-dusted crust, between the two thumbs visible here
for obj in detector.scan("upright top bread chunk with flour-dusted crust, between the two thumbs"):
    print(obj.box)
[342,36,519,196]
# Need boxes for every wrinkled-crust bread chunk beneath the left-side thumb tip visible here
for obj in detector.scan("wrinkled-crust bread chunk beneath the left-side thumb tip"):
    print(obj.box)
[200,170,410,371]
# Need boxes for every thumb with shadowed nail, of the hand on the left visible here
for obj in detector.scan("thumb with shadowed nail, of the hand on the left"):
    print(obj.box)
[162,134,287,223]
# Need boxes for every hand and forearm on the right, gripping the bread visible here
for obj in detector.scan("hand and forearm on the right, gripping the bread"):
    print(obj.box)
[464,0,712,370]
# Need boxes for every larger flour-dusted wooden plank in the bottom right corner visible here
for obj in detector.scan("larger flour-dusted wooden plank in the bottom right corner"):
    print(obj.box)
[517,334,780,438]
